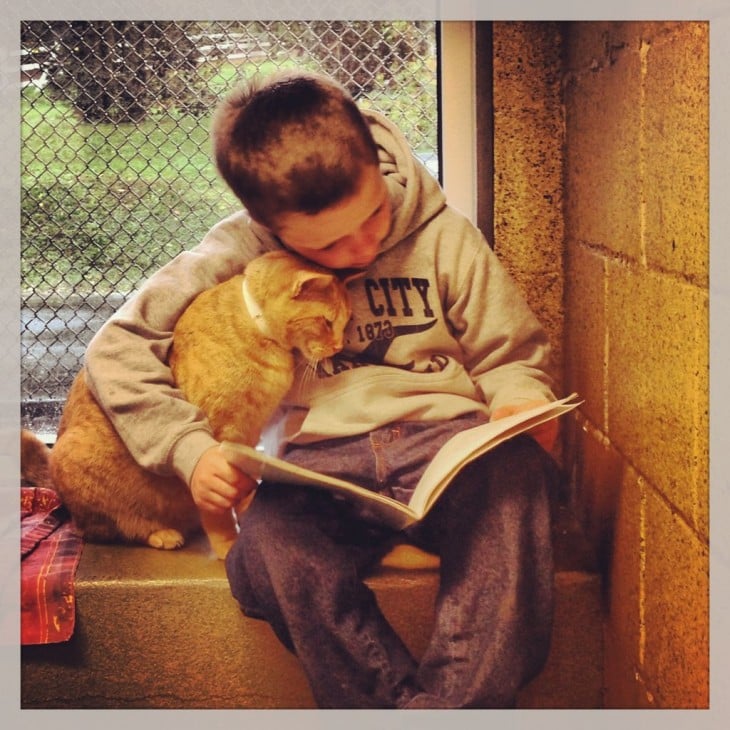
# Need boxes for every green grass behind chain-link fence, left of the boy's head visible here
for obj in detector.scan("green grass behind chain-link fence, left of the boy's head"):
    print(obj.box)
[21,86,239,296]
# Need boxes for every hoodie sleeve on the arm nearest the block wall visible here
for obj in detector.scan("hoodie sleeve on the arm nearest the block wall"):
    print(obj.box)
[440,213,555,411]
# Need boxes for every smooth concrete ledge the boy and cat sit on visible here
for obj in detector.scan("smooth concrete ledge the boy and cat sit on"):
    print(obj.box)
[21,506,602,709]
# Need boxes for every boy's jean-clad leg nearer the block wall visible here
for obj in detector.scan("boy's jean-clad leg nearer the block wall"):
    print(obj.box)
[406,436,555,708]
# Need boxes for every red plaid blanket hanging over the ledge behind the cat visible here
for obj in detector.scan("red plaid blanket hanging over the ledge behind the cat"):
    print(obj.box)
[20,487,83,644]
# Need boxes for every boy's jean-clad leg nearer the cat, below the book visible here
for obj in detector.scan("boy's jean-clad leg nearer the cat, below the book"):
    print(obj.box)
[226,484,416,708]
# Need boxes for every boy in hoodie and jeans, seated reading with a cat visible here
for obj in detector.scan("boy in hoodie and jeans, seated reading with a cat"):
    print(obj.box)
[86,72,557,708]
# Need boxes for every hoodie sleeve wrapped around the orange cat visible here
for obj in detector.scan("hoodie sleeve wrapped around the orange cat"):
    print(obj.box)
[84,214,272,484]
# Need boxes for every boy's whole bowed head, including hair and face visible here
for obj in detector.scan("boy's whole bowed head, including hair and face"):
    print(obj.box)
[211,71,391,269]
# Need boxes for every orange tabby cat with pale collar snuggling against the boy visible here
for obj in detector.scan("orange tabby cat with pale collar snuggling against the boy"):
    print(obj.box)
[51,252,350,558]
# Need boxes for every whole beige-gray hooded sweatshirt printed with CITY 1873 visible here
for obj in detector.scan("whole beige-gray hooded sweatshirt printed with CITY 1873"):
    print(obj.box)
[86,112,554,483]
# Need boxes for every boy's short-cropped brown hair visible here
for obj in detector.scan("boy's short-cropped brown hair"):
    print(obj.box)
[211,71,378,227]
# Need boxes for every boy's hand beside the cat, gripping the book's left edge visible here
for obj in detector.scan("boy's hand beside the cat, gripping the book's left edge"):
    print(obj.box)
[190,446,257,512]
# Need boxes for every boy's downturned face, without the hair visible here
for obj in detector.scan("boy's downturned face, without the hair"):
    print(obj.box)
[274,165,391,269]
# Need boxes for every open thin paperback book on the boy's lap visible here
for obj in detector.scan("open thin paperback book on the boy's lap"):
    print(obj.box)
[220,393,582,529]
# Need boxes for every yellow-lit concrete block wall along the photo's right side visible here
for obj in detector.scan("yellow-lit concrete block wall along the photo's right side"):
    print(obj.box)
[563,22,709,708]
